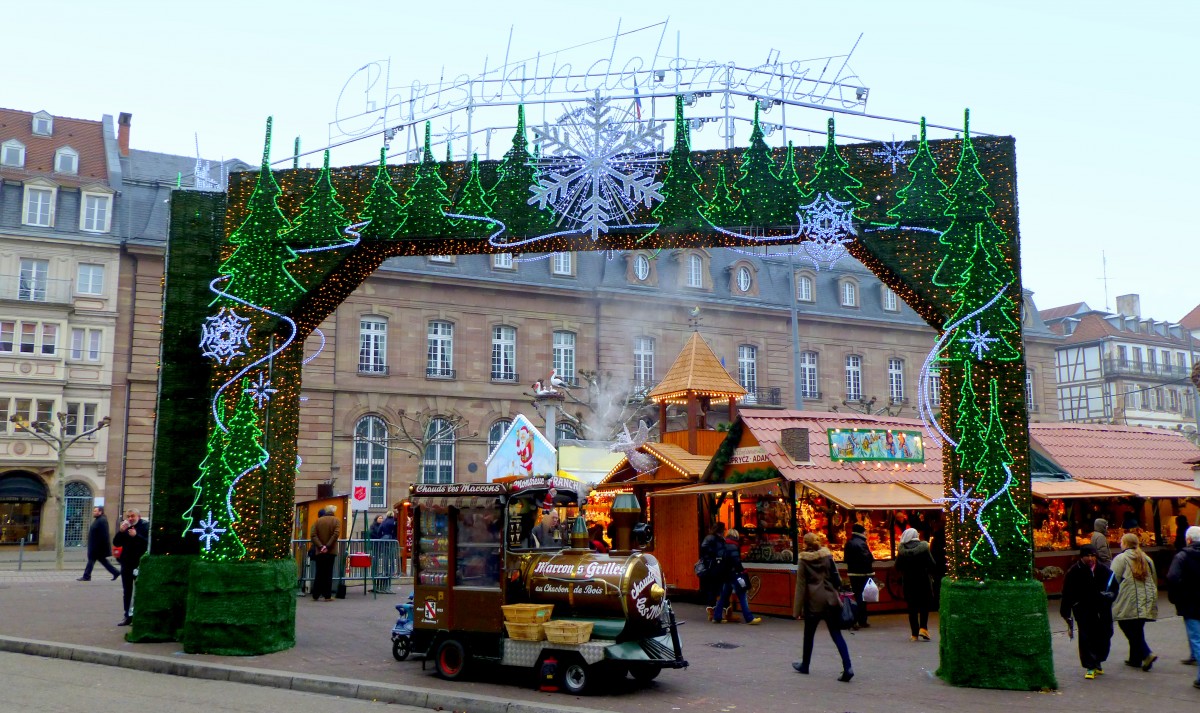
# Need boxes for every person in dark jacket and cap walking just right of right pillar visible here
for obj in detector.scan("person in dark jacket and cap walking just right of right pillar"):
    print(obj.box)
[1058,545,1116,679]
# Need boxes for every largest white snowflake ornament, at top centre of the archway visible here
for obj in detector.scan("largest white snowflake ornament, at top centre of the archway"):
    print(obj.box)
[529,91,662,240]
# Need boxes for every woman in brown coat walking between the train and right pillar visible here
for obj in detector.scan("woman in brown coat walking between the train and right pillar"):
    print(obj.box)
[792,532,854,683]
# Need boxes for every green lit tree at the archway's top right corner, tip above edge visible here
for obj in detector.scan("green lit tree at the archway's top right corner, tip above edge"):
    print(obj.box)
[934,109,1013,287]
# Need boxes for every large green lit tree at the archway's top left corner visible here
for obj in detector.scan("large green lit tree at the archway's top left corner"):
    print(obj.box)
[215,119,305,312]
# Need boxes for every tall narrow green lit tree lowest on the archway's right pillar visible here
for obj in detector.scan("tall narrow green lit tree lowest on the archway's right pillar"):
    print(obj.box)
[971,379,1033,571]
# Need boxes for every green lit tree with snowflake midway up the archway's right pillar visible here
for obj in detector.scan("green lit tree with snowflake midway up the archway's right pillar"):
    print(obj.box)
[942,232,1021,361]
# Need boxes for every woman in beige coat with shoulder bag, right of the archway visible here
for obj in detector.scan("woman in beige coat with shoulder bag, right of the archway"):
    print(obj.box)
[1112,533,1158,671]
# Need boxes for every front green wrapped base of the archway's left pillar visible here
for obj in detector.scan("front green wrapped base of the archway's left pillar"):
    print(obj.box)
[181,559,296,657]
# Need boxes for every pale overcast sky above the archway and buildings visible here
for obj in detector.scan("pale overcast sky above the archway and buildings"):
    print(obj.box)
[0,0,1200,320]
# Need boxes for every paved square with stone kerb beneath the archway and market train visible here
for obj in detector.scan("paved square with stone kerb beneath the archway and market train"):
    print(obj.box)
[0,571,1200,713]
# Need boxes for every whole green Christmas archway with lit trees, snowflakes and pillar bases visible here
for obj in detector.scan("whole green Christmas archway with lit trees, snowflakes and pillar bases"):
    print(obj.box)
[133,96,1055,689]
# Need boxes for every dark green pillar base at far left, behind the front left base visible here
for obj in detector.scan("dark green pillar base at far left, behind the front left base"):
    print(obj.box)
[125,555,199,643]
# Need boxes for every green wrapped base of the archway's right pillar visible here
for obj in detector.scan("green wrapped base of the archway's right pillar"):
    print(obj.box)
[937,577,1058,690]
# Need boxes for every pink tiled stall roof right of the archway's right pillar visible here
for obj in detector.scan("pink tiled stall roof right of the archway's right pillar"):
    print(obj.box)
[1030,424,1200,482]
